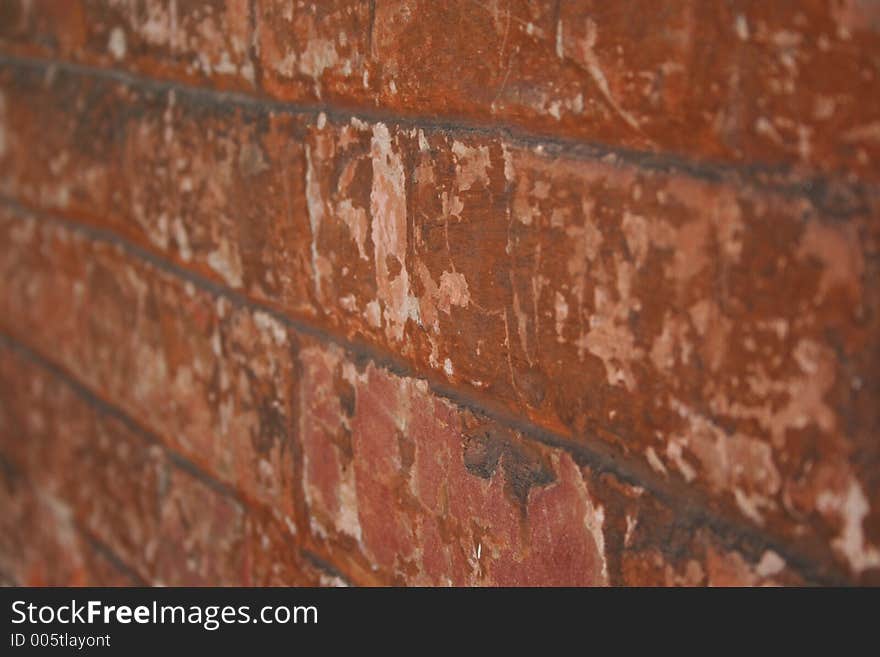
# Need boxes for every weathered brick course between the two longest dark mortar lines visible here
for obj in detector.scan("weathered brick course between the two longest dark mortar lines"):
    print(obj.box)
[4,64,880,572]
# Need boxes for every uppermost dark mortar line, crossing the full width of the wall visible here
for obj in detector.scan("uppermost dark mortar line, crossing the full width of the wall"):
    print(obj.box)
[0,53,880,208]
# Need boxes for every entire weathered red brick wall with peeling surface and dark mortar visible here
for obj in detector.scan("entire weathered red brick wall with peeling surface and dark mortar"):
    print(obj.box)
[0,0,880,585]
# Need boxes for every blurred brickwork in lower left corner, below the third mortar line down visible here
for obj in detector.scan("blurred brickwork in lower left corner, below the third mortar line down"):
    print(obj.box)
[0,338,341,586]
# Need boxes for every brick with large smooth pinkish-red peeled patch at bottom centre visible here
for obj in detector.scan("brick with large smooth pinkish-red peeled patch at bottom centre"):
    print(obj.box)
[301,346,604,585]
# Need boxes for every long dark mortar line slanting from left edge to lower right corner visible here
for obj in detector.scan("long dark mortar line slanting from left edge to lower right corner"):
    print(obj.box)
[0,196,849,584]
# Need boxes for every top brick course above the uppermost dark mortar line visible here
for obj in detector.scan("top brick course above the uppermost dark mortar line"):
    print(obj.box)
[0,0,880,179]
